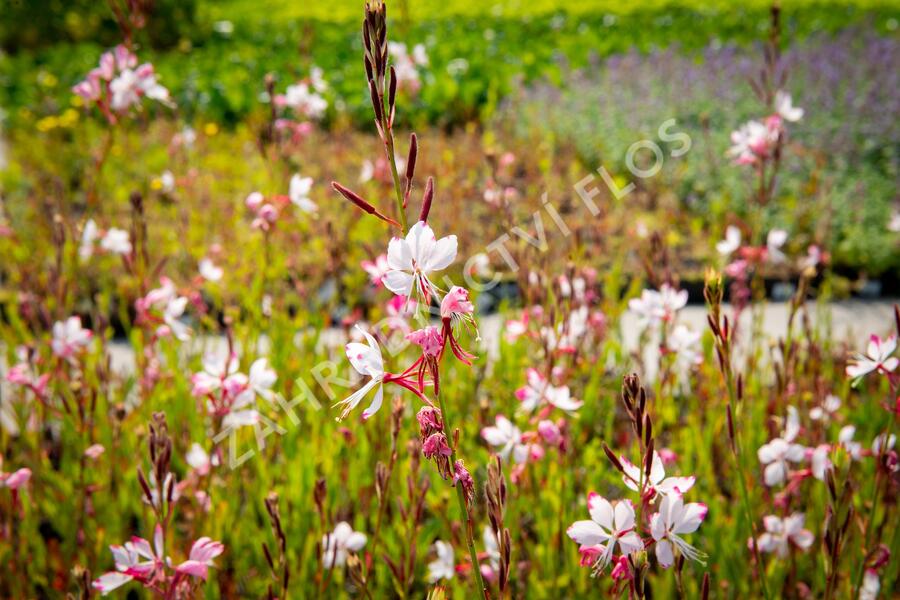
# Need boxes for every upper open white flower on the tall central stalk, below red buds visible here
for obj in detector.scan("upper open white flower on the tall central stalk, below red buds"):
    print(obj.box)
[383,221,456,299]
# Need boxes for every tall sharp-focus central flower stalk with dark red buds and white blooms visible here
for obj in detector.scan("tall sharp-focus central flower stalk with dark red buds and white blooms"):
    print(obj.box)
[332,0,488,598]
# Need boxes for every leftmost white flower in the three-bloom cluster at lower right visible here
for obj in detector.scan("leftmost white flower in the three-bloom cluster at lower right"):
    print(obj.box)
[566,492,644,573]
